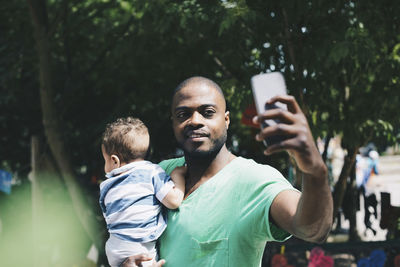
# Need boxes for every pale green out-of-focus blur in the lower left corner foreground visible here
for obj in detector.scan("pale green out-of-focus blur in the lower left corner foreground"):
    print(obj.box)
[0,176,95,267]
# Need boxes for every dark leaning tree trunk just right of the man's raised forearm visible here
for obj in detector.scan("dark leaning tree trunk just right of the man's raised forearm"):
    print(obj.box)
[333,147,359,221]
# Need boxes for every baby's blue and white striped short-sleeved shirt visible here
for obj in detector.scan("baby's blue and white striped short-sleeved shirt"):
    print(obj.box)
[99,161,174,243]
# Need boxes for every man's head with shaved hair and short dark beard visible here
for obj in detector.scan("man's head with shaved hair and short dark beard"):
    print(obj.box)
[172,83,229,158]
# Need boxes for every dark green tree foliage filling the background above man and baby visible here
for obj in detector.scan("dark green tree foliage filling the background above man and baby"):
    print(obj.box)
[0,0,400,264]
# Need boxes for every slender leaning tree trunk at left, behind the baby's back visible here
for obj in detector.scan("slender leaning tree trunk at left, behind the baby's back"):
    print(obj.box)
[28,0,103,251]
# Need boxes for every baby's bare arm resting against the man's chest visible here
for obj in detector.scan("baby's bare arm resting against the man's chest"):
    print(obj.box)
[161,167,186,209]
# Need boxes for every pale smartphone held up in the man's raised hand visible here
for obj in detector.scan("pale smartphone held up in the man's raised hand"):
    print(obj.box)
[251,72,287,146]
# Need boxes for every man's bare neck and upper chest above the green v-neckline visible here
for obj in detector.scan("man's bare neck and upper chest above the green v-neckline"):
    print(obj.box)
[185,145,236,198]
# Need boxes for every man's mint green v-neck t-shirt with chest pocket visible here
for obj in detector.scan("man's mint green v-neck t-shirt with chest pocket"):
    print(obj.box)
[159,157,293,267]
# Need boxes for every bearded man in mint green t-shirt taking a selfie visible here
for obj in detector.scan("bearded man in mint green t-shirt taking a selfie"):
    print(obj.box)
[123,77,332,267]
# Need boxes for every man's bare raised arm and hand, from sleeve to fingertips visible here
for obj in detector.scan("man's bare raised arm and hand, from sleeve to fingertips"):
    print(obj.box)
[254,96,333,243]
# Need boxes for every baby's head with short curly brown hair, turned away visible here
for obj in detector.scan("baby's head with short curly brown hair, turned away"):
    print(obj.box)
[101,117,150,173]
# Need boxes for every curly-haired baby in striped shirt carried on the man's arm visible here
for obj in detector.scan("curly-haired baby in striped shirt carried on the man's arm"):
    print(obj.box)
[100,117,185,267]
